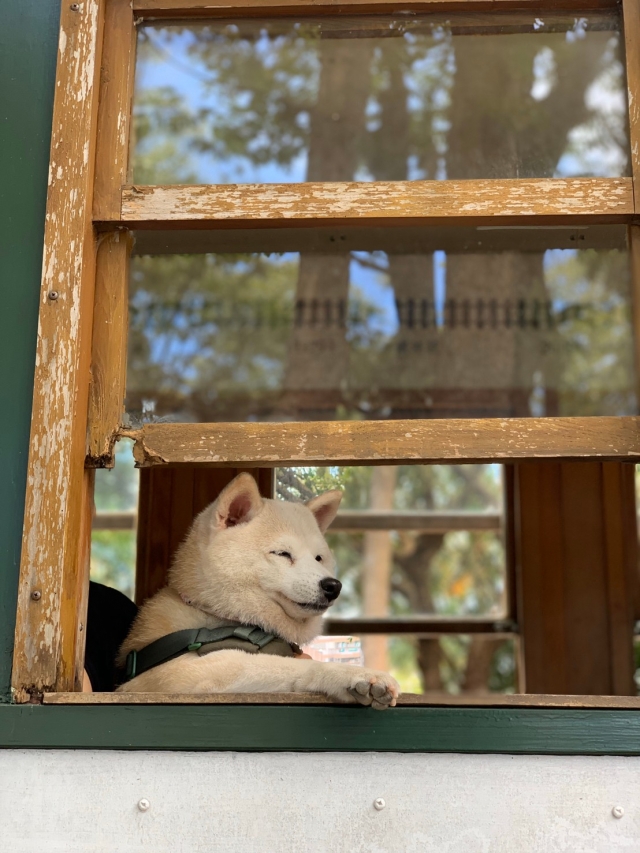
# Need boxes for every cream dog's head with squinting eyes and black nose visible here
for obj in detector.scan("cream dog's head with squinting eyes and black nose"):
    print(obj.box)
[170,474,342,643]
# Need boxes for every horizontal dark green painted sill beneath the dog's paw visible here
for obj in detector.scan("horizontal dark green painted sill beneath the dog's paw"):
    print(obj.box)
[0,705,640,755]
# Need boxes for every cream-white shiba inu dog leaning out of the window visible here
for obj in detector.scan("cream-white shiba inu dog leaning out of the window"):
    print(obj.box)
[118,474,400,710]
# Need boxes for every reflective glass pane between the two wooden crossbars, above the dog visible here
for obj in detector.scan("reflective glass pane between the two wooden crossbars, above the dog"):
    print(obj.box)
[126,226,636,424]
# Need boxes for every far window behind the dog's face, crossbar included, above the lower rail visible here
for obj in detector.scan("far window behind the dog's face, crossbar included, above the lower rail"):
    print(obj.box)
[276,465,506,619]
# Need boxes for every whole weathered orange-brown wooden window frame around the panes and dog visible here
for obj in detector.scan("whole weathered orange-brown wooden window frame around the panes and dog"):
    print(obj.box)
[12,0,640,707]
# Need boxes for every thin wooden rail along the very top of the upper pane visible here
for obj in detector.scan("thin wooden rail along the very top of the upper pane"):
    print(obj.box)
[133,0,616,19]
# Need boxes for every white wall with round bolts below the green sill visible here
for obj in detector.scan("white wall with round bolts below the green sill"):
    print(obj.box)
[0,750,640,853]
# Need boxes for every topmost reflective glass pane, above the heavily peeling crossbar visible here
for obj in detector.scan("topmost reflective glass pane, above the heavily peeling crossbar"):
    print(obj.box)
[133,12,629,184]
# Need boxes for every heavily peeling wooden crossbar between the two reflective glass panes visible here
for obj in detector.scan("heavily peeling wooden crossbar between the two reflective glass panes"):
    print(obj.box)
[121,178,633,228]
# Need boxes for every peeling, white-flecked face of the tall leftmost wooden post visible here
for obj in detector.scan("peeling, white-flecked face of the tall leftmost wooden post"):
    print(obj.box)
[14,0,104,686]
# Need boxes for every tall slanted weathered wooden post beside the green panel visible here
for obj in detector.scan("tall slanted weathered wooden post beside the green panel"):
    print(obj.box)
[12,0,104,701]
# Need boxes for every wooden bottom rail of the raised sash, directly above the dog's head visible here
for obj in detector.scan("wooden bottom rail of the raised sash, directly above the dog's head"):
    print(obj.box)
[121,417,640,468]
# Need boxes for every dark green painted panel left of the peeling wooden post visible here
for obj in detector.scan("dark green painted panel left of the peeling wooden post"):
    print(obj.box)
[0,0,60,702]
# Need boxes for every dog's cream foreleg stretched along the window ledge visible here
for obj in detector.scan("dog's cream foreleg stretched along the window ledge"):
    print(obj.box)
[120,650,400,710]
